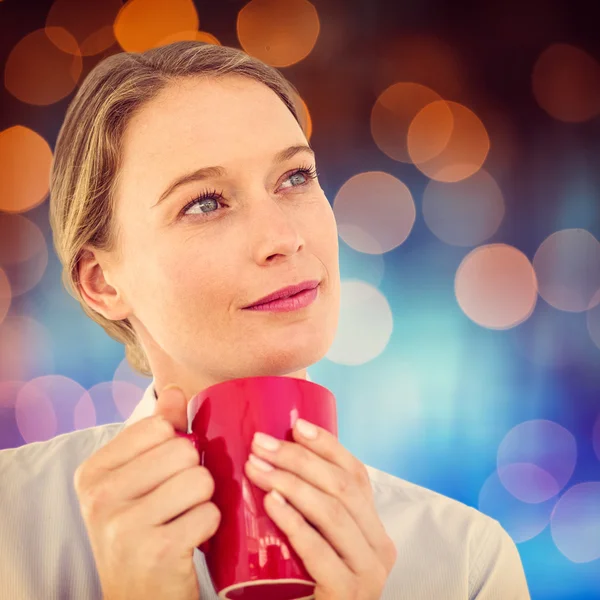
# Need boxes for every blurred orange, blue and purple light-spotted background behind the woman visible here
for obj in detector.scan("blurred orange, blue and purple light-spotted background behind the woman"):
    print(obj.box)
[0,0,600,600]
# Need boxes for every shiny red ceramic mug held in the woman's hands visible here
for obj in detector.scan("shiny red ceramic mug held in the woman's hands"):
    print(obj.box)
[177,376,338,600]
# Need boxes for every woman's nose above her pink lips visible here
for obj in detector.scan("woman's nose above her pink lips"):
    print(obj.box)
[249,197,305,264]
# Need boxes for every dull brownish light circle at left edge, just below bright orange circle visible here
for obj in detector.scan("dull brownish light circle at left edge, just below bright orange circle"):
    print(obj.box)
[0,212,48,297]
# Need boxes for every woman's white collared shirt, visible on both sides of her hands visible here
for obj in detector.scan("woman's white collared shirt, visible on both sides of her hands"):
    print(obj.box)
[0,382,530,600]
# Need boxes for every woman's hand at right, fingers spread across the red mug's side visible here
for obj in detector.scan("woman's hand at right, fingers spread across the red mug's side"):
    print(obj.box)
[245,419,397,600]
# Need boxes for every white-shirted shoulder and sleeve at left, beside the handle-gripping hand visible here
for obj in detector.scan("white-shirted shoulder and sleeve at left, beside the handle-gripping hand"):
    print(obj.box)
[0,423,124,599]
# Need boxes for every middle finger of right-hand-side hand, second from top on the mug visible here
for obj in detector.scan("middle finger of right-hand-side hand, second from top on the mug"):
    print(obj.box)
[252,432,390,556]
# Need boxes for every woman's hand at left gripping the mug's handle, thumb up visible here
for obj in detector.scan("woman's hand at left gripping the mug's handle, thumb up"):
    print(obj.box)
[74,387,221,600]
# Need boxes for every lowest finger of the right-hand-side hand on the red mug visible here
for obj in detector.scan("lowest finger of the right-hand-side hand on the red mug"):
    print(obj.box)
[264,494,353,598]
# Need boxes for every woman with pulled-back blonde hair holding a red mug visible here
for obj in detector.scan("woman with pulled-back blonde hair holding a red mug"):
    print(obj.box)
[0,42,529,600]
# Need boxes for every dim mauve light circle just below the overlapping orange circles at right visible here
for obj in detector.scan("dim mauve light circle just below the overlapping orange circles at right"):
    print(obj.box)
[423,169,505,246]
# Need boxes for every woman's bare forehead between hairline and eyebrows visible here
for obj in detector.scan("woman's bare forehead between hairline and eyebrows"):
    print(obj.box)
[122,75,305,176]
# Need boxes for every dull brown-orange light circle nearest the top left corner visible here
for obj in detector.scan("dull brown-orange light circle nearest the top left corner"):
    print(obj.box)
[4,27,83,106]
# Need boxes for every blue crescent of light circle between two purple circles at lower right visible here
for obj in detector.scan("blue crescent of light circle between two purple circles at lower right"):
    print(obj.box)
[477,471,555,544]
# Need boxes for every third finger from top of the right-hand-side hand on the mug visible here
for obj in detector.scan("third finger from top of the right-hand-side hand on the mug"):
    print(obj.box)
[246,455,376,574]
